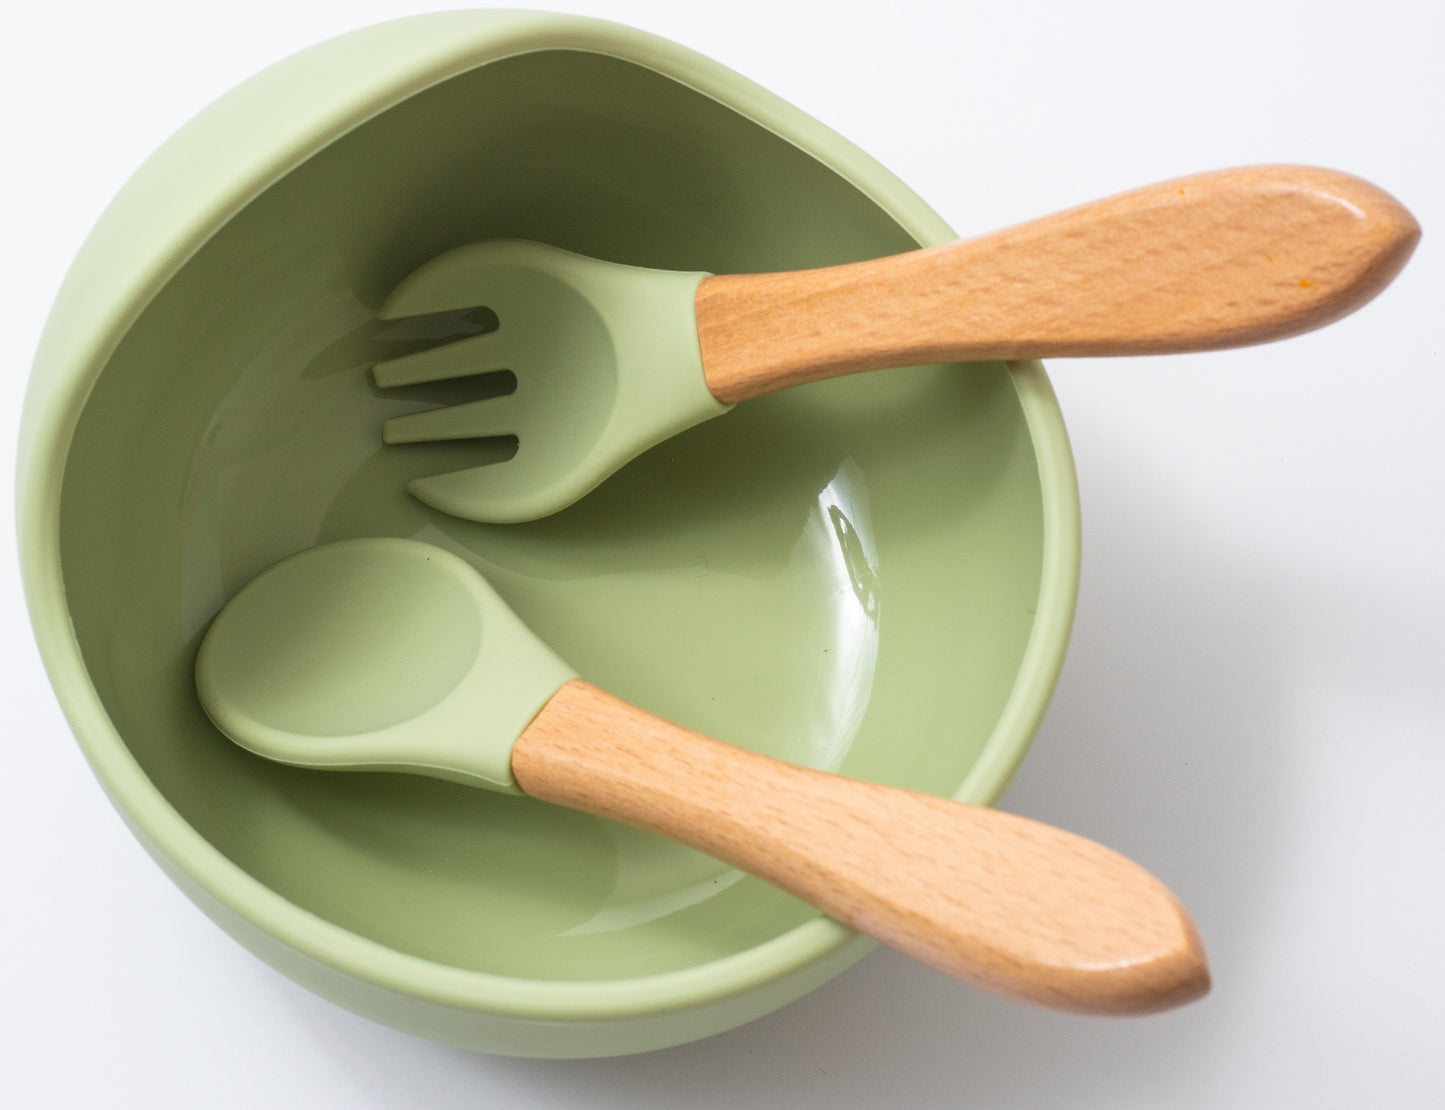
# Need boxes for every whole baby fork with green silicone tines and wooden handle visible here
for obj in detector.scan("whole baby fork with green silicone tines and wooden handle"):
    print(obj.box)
[373,166,1419,523]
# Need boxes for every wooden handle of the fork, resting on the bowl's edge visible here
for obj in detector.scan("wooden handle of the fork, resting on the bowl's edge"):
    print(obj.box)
[695,166,1420,402]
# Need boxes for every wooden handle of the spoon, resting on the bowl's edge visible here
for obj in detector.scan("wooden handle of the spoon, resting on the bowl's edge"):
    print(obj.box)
[512,681,1209,1013]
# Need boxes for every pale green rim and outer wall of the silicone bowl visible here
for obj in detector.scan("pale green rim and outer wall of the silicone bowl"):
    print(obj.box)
[17,12,1079,1022]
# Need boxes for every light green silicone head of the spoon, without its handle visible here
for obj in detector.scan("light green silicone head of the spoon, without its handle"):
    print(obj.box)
[195,536,577,793]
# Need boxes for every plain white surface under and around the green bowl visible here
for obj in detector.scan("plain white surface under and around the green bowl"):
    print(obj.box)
[0,0,1445,1109]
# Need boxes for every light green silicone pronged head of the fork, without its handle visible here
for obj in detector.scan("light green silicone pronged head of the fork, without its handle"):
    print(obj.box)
[373,240,731,523]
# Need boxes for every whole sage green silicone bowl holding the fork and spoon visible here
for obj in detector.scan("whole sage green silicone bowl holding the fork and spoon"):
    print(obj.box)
[19,12,1078,1057]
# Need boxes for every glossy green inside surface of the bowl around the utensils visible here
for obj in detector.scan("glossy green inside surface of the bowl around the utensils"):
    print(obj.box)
[61,51,1043,980]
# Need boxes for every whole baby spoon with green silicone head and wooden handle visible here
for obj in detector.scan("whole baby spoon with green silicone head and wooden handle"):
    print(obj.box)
[195,539,1209,1013]
